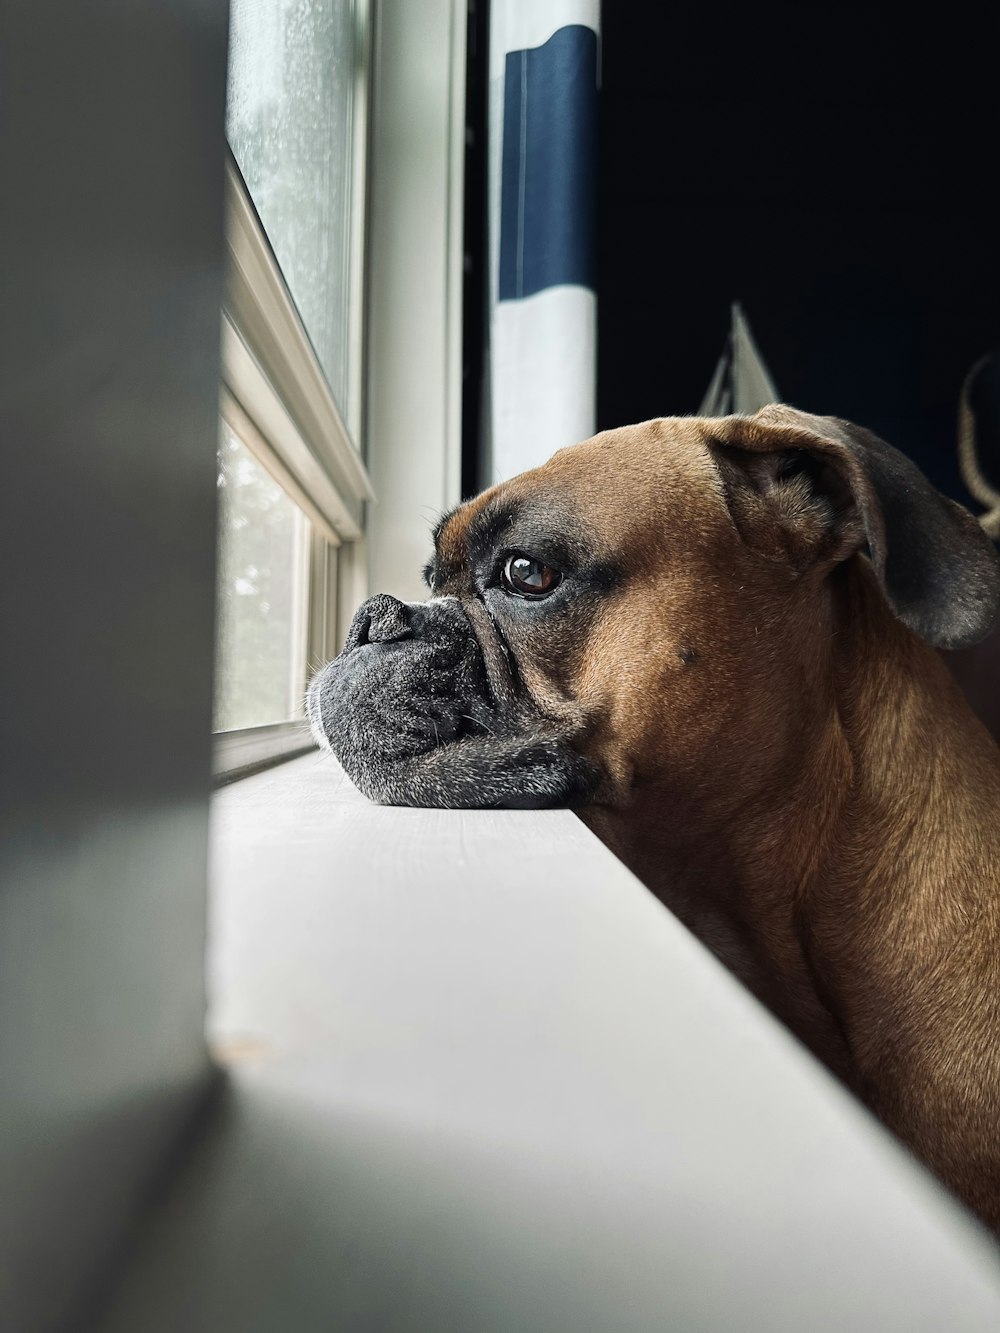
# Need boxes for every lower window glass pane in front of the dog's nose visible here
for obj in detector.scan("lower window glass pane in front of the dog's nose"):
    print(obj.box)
[213,423,309,732]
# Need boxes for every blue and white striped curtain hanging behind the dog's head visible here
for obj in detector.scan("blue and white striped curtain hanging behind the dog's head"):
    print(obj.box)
[483,0,600,483]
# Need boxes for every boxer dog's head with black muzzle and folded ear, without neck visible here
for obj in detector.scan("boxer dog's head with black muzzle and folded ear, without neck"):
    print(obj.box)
[308,407,1000,806]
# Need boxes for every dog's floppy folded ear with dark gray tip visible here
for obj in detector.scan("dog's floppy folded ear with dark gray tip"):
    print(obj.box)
[707,404,1000,648]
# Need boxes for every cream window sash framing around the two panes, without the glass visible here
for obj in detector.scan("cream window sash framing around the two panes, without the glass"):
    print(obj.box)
[212,0,375,781]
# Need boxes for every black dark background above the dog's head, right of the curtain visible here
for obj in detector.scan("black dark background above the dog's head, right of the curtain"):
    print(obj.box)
[597,0,1000,499]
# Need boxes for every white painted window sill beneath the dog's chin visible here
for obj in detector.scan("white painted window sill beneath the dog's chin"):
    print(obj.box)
[98,754,1000,1333]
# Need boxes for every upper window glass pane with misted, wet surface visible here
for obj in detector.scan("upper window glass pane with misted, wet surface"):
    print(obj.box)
[227,0,355,419]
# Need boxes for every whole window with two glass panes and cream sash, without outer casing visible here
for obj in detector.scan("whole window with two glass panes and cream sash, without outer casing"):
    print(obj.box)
[213,0,373,776]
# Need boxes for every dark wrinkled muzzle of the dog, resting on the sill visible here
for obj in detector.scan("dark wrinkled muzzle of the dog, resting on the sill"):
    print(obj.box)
[307,595,600,809]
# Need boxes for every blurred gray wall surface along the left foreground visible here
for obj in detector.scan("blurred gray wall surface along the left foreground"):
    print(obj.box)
[0,0,227,1333]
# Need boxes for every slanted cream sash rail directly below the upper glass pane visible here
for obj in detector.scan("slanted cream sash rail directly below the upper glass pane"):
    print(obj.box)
[225,155,375,501]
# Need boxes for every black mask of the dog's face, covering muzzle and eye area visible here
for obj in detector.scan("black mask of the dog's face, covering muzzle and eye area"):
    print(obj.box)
[308,489,613,808]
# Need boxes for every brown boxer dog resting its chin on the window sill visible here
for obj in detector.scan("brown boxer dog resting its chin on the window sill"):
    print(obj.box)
[309,407,1000,1226]
